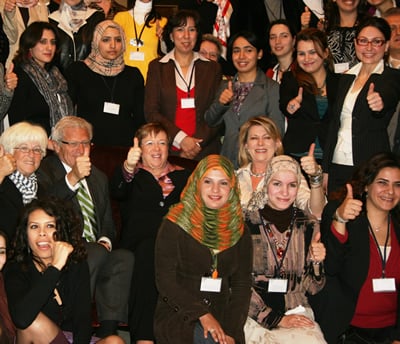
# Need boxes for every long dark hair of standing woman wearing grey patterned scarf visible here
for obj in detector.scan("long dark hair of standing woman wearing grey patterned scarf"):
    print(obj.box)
[13,21,59,67]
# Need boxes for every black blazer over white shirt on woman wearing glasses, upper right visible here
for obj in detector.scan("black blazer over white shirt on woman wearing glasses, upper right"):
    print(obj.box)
[322,66,400,172]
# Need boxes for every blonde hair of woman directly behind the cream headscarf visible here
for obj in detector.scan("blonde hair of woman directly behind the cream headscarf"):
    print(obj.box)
[239,116,283,167]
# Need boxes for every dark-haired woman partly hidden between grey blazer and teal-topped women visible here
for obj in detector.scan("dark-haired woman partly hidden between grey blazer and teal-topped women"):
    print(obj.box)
[266,19,296,84]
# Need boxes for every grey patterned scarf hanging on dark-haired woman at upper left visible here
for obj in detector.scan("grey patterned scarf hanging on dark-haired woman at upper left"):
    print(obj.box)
[22,59,74,127]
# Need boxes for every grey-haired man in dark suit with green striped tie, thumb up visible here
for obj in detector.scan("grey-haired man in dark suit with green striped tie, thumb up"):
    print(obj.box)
[37,116,133,338]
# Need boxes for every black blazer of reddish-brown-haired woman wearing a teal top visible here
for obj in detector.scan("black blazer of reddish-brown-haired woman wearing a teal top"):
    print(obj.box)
[279,71,339,154]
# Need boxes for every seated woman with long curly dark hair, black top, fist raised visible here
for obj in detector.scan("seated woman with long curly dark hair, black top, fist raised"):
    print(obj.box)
[5,200,123,344]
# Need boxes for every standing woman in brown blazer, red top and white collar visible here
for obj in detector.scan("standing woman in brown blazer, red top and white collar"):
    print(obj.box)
[144,10,222,160]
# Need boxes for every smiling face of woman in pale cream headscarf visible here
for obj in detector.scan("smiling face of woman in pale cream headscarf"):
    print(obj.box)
[267,170,299,210]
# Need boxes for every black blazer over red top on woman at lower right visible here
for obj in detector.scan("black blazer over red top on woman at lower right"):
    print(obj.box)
[311,201,400,344]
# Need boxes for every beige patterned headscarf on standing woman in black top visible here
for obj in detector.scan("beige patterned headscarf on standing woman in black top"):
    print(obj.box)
[83,20,125,76]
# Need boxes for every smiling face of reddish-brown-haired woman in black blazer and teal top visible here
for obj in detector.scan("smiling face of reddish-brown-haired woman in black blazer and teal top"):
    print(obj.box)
[297,41,328,74]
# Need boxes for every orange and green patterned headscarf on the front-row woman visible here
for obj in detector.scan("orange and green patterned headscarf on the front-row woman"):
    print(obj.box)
[166,155,244,251]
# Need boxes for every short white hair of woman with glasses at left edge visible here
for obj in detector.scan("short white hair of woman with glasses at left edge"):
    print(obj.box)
[0,122,48,156]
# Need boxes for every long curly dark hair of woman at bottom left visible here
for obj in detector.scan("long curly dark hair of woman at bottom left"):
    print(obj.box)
[10,198,87,269]
